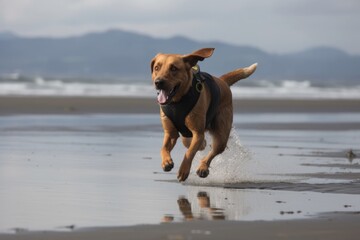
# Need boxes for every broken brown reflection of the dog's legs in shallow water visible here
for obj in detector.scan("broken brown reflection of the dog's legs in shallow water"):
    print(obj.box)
[163,191,226,222]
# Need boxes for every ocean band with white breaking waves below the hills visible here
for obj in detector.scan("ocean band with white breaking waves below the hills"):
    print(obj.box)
[0,73,360,99]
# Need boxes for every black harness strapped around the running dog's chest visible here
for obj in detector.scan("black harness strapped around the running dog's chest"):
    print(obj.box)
[161,67,220,137]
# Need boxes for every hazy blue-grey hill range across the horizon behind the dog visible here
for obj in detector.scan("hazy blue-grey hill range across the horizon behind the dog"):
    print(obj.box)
[0,30,360,85]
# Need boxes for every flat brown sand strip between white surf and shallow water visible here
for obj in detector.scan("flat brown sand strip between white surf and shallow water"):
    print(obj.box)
[0,96,360,115]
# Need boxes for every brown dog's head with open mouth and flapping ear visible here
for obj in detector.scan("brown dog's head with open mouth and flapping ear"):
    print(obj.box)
[151,48,214,105]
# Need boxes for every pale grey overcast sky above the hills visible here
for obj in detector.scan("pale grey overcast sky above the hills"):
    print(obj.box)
[0,0,360,54]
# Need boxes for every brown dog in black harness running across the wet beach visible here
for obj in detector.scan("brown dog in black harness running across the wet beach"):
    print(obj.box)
[151,48,257,181]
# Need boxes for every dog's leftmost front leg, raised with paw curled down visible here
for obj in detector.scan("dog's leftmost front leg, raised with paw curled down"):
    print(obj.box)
[160,132,179,172]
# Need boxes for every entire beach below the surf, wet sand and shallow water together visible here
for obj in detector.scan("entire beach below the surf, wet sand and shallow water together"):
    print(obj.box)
[0,96,360,239]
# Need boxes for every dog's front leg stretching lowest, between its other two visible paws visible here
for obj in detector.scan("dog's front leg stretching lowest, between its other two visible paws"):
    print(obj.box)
[178,132,205,182]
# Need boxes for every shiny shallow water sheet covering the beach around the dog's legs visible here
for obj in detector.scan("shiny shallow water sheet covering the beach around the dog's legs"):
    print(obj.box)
[0,113,360,232]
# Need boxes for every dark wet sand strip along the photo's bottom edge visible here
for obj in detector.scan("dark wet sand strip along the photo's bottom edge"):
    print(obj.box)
[0,213,360,240]
